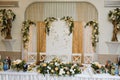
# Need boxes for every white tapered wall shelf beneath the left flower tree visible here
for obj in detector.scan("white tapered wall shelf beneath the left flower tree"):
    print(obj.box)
[2,39,16,51]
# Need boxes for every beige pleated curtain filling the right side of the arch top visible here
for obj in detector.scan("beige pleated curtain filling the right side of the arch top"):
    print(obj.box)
[76,2,98,22]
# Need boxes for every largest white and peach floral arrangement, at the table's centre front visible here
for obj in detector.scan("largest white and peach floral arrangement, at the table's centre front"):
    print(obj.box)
[37,58,81,76]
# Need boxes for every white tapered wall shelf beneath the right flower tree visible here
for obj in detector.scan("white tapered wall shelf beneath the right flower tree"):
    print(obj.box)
[106,42,120,54]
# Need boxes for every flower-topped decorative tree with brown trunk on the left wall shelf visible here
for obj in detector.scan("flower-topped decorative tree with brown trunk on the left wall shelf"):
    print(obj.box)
[0,9,16,39]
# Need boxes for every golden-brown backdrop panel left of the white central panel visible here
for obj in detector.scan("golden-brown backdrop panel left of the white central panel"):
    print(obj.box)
[37,22,46,61]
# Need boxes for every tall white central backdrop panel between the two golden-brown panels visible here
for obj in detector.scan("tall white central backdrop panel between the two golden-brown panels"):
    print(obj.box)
[46,19,72,55]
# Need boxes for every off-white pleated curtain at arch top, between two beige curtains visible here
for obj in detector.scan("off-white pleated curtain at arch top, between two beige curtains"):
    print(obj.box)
[43,2,76,19]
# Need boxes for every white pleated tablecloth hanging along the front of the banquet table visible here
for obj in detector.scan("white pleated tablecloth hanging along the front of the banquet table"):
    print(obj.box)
[0,71,120,80]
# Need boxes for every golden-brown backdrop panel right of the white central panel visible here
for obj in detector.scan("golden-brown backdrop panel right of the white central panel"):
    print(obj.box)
[72,21,83,62]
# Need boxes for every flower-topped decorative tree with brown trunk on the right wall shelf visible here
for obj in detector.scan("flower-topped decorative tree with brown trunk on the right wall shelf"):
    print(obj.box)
[108,8,120,41]
